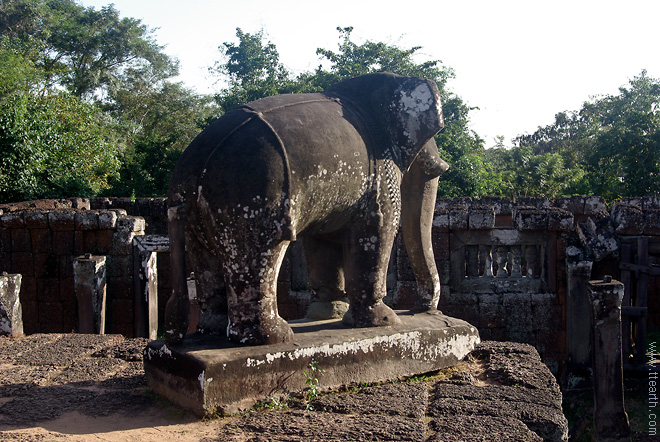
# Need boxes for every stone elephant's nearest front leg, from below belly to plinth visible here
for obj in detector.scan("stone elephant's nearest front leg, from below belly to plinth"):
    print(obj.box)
[343,225,401,327]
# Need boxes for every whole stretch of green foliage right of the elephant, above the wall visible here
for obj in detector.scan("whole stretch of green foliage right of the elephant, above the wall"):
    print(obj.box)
[486,72,660,201]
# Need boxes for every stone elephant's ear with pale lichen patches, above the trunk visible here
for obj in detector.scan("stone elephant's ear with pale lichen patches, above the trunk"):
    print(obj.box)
[390,77,444,172]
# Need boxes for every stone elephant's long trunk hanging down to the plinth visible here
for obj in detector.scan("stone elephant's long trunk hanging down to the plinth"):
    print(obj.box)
[401,139,449,311]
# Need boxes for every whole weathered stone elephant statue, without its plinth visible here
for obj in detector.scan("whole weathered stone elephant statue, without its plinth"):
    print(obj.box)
[165,73,447,345]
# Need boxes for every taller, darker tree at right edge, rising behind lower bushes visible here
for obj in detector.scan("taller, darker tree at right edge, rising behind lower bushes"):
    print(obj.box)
[516,71,660,200]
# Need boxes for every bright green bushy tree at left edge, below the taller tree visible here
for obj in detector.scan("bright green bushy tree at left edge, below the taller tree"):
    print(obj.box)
[0,93,119,202]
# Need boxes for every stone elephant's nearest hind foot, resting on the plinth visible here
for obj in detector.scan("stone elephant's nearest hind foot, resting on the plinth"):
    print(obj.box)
[227,316,293,345]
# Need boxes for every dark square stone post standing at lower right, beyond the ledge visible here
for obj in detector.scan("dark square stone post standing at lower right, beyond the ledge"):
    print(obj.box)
[588,276,630,442]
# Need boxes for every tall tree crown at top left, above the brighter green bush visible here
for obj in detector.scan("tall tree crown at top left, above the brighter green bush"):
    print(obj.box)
[0,0,177,98]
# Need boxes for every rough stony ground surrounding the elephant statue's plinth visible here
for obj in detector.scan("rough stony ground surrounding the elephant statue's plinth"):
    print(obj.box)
[0,334,568,442]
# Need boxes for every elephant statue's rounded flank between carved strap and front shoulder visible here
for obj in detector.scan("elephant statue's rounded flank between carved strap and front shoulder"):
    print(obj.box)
[255,96,374,232]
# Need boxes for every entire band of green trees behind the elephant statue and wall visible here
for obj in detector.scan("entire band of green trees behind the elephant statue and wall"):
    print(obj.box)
[0,0,660,202]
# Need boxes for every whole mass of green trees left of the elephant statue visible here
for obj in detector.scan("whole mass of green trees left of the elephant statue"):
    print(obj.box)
[0,0,213,202]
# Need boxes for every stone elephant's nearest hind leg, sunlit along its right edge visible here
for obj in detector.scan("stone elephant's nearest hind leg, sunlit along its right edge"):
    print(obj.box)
[225,241,293,345]
